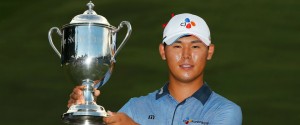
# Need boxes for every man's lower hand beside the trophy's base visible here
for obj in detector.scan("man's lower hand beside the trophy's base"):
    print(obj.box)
[103,111,138,125]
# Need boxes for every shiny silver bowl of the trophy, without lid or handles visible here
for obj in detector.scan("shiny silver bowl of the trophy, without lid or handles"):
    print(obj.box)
[61,23,116,88]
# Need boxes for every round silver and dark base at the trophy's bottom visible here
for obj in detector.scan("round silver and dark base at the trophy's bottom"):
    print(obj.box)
[62,104,107,125]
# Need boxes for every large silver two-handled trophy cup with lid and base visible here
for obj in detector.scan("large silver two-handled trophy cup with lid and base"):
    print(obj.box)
[48,1,131,125]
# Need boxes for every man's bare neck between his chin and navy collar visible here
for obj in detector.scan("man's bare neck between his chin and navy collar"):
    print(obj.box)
[168,78,204,102]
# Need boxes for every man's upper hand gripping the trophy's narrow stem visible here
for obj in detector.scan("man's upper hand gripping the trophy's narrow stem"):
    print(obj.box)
[68,85,100,108]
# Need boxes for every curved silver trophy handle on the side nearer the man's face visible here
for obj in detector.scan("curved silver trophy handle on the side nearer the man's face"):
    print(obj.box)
[111,21,132,62]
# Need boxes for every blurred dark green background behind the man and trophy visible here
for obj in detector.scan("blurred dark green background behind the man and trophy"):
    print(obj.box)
[0,0,300,125]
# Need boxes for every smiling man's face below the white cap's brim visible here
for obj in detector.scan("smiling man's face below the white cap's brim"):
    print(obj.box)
[165,36,208,82]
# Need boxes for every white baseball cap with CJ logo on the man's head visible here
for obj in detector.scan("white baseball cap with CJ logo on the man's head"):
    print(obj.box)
[162,13,211,46]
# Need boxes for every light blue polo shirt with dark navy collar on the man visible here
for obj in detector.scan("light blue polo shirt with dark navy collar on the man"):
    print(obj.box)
[119,83,242,125]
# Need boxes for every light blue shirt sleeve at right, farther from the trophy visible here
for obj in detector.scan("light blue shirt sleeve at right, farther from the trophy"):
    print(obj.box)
[210,105,242,125]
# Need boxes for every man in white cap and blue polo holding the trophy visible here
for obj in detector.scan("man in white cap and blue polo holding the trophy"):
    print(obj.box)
[68,13,242,125]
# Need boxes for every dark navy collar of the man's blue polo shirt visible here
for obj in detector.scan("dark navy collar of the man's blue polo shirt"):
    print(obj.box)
[156,83,212,105]
